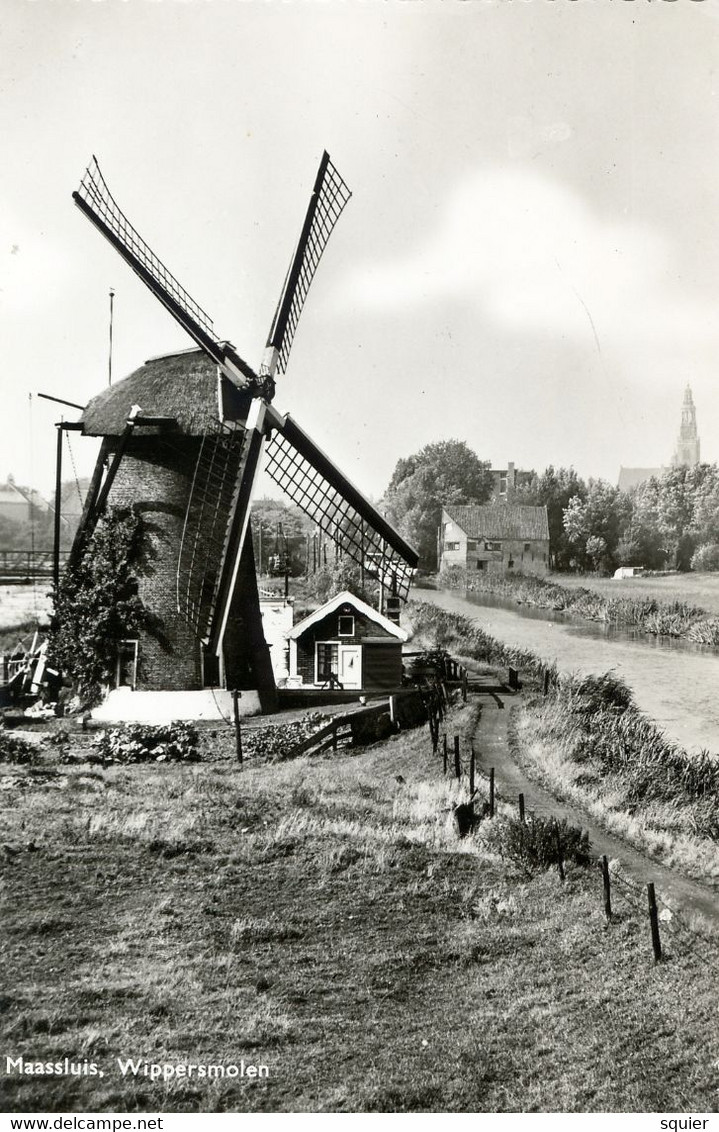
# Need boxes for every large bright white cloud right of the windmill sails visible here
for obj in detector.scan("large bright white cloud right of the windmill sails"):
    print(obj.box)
[340,169,719,344]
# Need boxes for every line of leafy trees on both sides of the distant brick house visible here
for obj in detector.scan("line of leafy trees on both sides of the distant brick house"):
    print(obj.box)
[382,440,719,573]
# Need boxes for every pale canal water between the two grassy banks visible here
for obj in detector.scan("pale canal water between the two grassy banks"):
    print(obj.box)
[413,590,719,754]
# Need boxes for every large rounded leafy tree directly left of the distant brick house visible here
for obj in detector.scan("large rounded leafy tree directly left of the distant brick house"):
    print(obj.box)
[382,440,493,569]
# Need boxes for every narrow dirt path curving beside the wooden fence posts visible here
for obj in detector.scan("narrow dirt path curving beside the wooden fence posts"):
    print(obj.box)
[474,694,719,928]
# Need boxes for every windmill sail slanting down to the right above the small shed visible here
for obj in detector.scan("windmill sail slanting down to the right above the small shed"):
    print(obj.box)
[265,410,419,599]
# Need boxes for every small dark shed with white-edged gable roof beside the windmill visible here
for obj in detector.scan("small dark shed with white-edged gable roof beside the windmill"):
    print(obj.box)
[288,590,406,692]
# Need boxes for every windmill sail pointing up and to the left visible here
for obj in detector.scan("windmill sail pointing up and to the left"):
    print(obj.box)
[72,156,259,386]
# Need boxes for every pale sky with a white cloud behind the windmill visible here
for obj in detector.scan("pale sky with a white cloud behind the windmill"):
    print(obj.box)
[0,0,719,498]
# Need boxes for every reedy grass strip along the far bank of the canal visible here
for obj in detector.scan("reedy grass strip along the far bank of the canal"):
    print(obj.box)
[438,567,719,648]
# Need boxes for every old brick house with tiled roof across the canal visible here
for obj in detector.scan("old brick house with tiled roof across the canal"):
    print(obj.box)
[438,503,549,574]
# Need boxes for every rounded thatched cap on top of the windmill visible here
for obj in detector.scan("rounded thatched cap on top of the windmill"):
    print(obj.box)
[80,349,249,436]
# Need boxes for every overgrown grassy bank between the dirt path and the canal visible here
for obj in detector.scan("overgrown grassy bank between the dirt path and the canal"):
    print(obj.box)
[410,603,719,886]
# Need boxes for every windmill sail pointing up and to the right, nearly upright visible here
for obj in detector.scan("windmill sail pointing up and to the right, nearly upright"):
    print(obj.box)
[263,151,352,375]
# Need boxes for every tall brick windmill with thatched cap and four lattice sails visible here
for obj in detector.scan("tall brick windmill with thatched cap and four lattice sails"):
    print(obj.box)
[72,153,418,710]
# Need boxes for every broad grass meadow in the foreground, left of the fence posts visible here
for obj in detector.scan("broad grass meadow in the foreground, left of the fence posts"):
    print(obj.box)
[0,709,719,1112]
